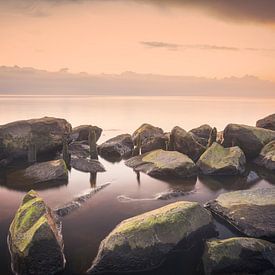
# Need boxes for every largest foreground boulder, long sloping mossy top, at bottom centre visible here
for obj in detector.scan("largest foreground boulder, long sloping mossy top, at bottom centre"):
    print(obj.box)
[88,201,215,274]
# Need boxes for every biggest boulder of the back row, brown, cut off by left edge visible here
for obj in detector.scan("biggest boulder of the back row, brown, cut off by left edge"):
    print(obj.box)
[0,117,72,163]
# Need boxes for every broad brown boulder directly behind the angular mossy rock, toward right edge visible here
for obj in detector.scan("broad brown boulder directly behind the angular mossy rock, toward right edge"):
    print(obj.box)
[223,124,275,161]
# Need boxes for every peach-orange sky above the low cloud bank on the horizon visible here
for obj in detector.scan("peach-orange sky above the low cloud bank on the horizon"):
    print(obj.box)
[0,0,275,81]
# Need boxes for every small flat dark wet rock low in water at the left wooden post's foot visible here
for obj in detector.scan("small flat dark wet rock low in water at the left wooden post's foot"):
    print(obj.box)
[71,158,105,173]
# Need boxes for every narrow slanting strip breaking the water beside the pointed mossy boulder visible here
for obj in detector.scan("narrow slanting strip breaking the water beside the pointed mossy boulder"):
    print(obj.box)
[54,183,110,217]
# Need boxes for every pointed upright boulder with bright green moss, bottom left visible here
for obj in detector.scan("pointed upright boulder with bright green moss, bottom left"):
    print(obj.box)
[8,191,65,275]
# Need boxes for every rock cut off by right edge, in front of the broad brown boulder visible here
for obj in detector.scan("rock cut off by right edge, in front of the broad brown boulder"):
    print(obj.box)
[255,140,275,171]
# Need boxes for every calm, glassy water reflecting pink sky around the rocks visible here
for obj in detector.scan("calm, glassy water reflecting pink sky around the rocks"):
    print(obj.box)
[0,96,275,275]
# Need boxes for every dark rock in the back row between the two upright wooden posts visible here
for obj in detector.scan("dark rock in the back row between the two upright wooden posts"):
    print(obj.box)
[98,134,134,159]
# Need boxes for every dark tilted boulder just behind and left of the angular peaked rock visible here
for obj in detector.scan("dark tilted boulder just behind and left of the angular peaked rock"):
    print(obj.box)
[170,126,206,161]
